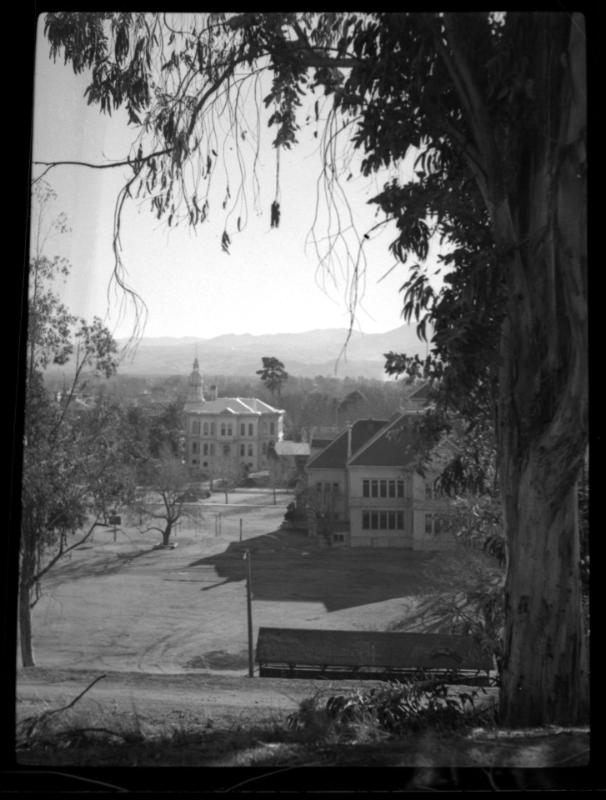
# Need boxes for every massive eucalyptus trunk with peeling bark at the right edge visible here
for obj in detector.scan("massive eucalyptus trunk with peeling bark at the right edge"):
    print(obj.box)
[492,15,589,726]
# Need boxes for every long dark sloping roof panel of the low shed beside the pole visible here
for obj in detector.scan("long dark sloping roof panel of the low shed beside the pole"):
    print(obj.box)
[256,628,493,670]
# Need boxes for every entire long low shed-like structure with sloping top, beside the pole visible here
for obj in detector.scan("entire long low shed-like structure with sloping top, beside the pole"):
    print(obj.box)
[256,628,494,685]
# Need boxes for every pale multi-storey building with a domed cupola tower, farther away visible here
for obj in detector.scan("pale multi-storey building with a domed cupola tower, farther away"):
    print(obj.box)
[183,358,284,476]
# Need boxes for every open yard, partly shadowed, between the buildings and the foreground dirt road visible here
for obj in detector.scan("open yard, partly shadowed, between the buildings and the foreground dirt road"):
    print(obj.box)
[26,492,476,674]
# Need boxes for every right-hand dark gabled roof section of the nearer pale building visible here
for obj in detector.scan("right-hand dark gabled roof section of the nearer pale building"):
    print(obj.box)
[347,414,430,467]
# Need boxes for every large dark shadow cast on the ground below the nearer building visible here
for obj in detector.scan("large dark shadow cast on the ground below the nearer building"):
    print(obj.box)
[188,530,460,611]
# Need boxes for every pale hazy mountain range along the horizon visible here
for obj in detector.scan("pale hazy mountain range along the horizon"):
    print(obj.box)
[113,325,426,378]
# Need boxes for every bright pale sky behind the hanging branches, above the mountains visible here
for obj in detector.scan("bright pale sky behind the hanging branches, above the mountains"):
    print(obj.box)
[33,14,442,338]
